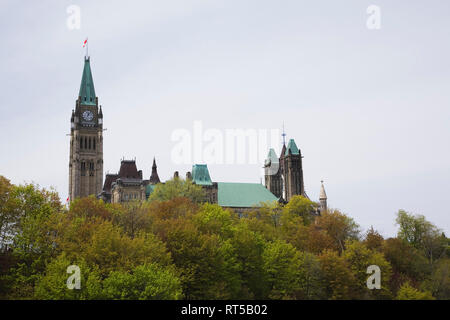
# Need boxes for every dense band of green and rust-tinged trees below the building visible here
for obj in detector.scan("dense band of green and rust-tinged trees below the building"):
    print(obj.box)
[0,176,450,299]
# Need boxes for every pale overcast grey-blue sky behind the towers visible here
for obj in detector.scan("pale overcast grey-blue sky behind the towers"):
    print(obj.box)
[0,0,450,236]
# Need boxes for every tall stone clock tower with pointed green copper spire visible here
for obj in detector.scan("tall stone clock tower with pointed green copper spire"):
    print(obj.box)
[69,57,103,201]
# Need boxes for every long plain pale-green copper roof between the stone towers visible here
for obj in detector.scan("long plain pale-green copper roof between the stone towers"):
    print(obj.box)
[217,182,278,208]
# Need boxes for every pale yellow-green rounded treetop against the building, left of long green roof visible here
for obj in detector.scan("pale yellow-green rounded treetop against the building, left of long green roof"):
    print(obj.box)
[148,178,206,203]
